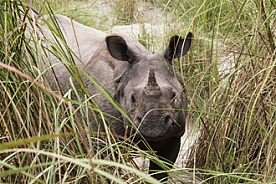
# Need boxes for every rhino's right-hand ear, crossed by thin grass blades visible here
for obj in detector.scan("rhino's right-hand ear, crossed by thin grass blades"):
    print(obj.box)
[164,32,193,61]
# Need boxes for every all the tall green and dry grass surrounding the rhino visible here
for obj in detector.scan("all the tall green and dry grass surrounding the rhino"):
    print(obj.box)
[0,0,276,183]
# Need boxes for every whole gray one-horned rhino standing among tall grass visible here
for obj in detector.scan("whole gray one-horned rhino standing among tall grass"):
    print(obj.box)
[34,15,192,179]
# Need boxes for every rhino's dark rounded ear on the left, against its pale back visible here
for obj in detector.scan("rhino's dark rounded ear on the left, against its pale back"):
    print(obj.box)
[105,35,129,61]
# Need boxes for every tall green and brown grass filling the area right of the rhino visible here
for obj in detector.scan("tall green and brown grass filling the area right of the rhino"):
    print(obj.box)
[183,1,276,183]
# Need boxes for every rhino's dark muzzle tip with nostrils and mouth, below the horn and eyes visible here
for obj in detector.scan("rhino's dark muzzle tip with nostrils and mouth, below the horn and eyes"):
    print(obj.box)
[134,116,174,140]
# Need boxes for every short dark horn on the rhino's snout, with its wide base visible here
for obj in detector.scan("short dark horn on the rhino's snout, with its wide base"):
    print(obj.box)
[144,67,161,96]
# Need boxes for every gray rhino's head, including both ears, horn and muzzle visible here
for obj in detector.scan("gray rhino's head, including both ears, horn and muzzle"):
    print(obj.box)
[106,33,193,141]
